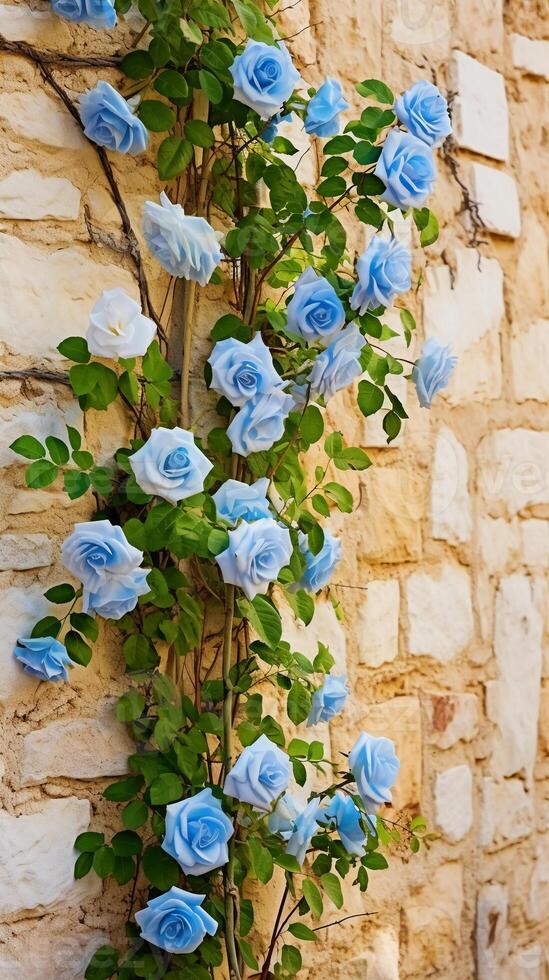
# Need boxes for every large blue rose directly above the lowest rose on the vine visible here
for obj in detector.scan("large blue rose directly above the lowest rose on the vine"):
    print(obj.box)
[162,789,234,875]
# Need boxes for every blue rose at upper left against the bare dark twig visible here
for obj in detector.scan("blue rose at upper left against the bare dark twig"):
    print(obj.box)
[80,82,149,156]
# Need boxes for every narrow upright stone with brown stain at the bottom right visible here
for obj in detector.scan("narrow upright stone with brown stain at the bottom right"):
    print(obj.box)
[477,884,509,980]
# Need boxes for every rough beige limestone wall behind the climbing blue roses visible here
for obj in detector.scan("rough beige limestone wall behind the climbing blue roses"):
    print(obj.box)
[0,0,549,980]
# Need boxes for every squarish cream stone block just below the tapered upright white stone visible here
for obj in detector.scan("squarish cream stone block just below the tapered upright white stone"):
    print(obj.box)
[406,564,473,661]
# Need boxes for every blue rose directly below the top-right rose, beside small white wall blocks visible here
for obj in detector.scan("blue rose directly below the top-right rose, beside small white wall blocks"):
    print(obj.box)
[374,129,437,211]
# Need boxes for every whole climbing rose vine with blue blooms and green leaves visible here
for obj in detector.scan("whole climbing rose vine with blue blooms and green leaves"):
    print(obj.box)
[12,0,455,980]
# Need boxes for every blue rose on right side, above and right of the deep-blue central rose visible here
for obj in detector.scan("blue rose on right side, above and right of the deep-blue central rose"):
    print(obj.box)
[350,235,412,316]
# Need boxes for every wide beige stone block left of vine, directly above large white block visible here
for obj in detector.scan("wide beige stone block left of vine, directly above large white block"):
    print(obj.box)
[19,702,135,786]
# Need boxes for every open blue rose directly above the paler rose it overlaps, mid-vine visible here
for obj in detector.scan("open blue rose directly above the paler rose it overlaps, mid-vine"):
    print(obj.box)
[208,333,283,406]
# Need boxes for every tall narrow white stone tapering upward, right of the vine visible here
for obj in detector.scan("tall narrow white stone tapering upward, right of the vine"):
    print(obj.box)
[431,427,473,544]
